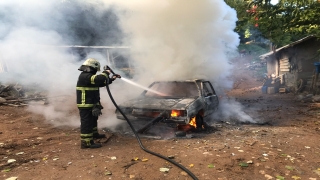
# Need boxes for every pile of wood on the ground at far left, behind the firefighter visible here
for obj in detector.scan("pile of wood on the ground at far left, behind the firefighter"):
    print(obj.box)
[0,84,47,107]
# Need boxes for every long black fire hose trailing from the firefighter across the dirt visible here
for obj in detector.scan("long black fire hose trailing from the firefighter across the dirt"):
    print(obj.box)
[106,78,198,180]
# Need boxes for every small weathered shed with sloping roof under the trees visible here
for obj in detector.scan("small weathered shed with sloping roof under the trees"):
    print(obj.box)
[260,35,320,91]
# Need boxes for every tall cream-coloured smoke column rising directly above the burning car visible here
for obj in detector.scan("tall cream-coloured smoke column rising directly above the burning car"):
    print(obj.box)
[109,0,239,86]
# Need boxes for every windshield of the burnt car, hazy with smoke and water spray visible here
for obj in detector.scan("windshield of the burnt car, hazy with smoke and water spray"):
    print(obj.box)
[145,81,199,97]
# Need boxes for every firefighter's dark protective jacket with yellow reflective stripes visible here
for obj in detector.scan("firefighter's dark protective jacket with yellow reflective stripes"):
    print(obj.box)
[76,71,112,109]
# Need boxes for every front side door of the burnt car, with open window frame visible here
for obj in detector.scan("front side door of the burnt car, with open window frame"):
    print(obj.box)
[202,81,219,116]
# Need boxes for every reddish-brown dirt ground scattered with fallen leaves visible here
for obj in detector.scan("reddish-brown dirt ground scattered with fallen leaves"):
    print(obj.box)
[0,56,320,180]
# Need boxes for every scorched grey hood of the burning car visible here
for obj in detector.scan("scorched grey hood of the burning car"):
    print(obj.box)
[120,98,196,109]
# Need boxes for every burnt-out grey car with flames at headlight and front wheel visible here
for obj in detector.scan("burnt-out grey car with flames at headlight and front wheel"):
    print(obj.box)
[116,79,219,132]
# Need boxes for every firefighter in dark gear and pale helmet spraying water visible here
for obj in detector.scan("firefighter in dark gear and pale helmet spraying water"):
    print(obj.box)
[76,58,117,149]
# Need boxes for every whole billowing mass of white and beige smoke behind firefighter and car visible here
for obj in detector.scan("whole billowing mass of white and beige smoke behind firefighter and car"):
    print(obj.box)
[0,0,251,129]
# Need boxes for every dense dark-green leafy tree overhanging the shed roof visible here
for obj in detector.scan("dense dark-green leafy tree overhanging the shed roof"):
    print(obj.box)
[247,0,320,46]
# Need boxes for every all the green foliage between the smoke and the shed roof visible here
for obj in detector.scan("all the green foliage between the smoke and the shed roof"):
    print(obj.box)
[225,0,320,48]
